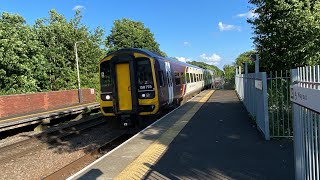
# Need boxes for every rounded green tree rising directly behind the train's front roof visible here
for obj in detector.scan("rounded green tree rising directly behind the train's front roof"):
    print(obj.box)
[105,18,166,56]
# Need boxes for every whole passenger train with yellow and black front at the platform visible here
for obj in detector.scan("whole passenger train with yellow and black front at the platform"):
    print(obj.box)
[99,48,215,126]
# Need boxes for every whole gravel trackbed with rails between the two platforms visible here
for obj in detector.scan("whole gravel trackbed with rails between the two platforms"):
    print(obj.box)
[0,111,165,179]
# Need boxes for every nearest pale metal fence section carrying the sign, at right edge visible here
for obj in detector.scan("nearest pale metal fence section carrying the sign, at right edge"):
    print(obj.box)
[291,66,320,180]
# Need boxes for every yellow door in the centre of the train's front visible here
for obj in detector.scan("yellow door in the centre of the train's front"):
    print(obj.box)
[115,63,132,111]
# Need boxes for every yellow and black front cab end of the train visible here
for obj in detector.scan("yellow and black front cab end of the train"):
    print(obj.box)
[100,49,158,121]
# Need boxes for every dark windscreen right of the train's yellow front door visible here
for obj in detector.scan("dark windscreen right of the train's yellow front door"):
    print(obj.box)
[137,58,153,86]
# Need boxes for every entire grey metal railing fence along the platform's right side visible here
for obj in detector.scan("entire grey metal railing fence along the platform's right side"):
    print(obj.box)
[235,63,320,180]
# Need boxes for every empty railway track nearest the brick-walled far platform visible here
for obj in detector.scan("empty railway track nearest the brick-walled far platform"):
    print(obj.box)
[0,114,105,164]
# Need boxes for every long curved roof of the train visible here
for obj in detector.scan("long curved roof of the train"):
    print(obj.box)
[107,48,211,71]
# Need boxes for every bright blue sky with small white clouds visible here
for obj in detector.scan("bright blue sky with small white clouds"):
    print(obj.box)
[0,0,254,69]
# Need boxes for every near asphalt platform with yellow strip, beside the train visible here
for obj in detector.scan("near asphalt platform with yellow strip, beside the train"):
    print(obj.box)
[68,90,294,180]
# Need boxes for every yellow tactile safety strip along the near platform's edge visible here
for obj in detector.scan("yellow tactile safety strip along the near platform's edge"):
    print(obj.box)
[115,90,214,179]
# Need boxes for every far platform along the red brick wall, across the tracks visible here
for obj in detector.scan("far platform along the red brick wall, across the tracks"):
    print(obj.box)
[0,102,100,132]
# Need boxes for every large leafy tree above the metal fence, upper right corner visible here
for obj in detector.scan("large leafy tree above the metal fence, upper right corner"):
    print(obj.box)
[248,0,320,71]
